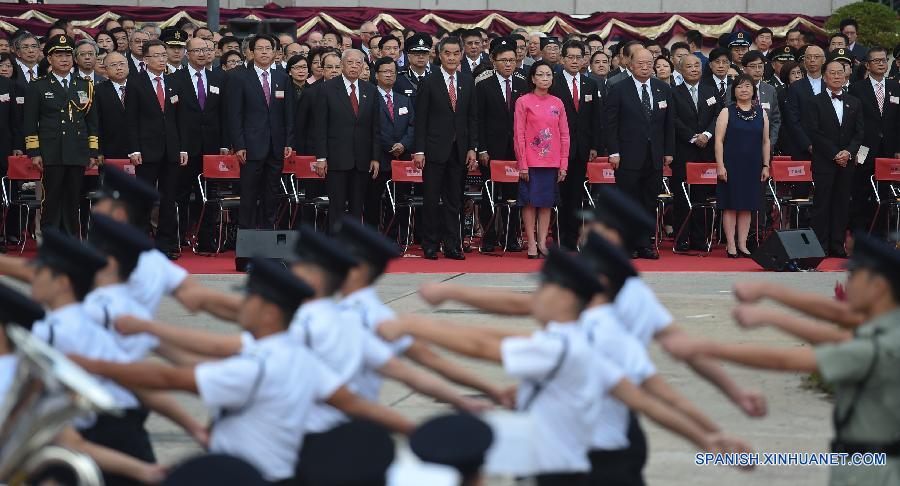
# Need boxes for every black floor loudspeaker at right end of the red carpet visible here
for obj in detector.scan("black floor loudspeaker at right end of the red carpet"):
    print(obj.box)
[752,229,825,272]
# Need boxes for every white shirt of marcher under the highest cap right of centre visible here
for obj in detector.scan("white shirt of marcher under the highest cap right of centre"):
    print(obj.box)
[613,277,672,347]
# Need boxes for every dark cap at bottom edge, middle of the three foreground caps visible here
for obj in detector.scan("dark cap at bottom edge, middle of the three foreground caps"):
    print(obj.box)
[303,420,394,486]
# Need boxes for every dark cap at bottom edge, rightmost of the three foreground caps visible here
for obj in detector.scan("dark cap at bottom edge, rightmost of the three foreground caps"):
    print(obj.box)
[409,413,494,482]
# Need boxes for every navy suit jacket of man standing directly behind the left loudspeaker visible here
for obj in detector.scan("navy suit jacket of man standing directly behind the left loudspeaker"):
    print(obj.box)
[225,66,294,160]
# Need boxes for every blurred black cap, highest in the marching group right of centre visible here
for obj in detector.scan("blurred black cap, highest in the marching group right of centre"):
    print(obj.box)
[581,186,656,249]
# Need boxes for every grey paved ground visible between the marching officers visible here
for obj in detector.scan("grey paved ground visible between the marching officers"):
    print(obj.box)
[139,273,842,486]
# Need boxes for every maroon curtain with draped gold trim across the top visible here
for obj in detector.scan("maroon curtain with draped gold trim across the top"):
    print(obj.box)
[0,4,825,42]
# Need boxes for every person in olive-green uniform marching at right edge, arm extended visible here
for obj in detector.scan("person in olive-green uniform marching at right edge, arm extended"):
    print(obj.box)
[669,234,900,486]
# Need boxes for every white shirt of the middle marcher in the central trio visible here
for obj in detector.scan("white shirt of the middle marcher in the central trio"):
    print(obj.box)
[289,298,393,433]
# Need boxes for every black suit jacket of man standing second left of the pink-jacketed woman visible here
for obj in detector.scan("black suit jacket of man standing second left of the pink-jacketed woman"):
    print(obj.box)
[412,68,478,163]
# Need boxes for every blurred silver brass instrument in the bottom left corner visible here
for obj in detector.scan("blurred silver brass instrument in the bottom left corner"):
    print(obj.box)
[0,325,115,486]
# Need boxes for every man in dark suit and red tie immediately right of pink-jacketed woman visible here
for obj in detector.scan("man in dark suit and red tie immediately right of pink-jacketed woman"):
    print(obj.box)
[550,41,604,248]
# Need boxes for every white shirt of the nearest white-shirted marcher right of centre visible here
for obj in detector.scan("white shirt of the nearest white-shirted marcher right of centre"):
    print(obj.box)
[501,323,624,474]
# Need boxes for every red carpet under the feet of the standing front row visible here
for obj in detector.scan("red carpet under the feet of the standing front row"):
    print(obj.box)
[165,249,845,274]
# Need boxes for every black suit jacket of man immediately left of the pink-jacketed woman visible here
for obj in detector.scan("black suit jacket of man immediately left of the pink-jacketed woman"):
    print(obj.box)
[475,74,528,160]
